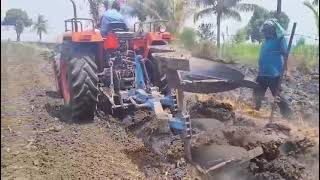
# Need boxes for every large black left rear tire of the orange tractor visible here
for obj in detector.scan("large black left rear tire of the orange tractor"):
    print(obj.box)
[68,56,99,121]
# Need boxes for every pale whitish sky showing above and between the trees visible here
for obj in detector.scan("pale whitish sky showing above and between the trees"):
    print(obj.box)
[1,0,317,43]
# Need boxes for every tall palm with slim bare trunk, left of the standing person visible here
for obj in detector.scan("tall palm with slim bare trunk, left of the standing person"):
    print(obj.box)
[194,0,260,47]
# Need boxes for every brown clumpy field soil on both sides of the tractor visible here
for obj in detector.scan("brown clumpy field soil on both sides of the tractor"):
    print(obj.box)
[1,43,319,180]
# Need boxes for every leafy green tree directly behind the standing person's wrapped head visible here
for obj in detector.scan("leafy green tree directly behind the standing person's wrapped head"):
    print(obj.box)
[246,8,290,43]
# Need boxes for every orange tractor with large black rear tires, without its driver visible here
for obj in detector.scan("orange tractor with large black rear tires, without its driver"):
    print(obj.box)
[54,0,173,121]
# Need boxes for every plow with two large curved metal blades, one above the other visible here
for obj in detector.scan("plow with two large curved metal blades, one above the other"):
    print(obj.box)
[154,53,263,177]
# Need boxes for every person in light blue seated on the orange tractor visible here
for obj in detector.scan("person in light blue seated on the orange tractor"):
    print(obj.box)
[100,0,127,37]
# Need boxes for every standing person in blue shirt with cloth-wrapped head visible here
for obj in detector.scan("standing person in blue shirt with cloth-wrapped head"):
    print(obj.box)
[254,19,291,117]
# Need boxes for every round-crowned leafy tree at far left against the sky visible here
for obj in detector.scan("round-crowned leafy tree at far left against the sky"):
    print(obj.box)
[2,9,32,41]
